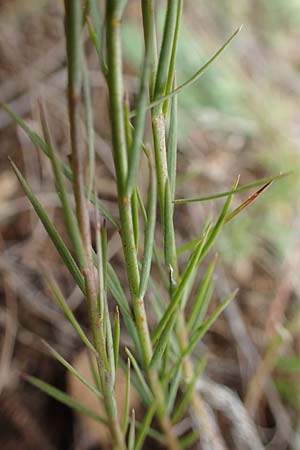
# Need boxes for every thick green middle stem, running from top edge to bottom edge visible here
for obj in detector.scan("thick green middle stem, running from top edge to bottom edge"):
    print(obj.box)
[106,0,180,450]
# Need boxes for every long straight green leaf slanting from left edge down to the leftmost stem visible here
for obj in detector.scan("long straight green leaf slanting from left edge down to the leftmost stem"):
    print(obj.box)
[11,161,85,294]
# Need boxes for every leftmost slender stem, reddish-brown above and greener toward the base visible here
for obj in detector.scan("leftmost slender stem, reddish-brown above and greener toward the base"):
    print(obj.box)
[65,0,126,450]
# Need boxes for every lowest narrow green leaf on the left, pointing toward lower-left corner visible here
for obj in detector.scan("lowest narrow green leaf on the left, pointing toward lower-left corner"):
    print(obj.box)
[23,375,107,425]
